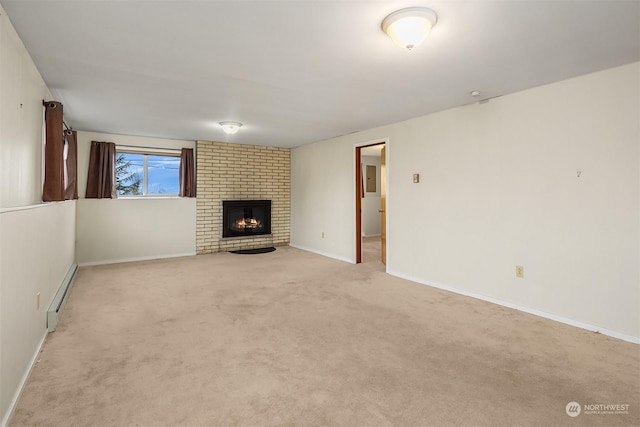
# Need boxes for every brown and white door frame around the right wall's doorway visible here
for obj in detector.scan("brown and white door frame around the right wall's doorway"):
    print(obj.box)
[353,138,389,269]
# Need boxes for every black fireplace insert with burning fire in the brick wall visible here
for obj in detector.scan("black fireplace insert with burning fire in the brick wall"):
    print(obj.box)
[222,200,271,237]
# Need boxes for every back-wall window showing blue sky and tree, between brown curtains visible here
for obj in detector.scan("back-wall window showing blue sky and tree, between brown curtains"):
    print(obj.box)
[115,147,180,197]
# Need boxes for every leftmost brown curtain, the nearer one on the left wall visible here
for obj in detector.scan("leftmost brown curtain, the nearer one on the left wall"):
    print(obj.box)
[42,101,65,202]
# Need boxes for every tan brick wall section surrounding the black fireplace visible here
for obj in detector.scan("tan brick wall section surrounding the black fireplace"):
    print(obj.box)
[196,141,291,254]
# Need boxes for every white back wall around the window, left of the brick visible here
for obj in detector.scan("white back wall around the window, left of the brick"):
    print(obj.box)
[77,132,196,265]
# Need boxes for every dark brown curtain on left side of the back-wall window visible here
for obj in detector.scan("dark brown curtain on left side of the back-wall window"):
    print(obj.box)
[85,141,116,199]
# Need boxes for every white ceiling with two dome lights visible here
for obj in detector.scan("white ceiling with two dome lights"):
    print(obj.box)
[0,0,640,147]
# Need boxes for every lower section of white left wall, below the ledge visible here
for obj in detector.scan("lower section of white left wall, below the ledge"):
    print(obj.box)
[0,201,76,419]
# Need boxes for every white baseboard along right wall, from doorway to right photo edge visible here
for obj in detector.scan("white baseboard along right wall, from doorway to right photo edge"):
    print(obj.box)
[387,270,640,344]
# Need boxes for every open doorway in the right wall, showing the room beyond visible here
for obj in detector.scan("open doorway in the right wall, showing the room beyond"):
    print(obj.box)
[355,142,386,264]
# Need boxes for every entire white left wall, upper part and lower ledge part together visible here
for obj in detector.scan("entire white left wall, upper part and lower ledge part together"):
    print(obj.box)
[0,7,76,425]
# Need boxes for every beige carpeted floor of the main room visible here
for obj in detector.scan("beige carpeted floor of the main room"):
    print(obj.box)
[10,247,640,426]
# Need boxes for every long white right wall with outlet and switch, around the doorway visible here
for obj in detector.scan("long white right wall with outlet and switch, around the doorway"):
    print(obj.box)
[291,63,640,340]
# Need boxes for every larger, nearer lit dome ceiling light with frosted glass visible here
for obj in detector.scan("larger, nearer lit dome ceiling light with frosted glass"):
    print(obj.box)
[382,7,438,50]
